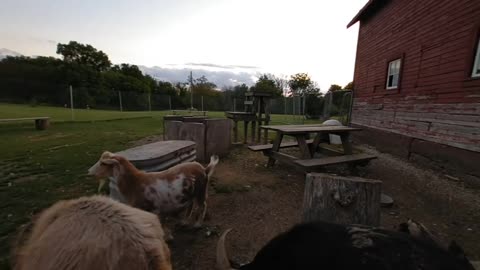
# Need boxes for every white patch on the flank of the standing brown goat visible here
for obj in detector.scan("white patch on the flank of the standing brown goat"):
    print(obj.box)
[144,173,187,213]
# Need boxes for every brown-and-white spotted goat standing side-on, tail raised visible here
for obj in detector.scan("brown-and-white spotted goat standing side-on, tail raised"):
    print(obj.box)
[88,151,218,227]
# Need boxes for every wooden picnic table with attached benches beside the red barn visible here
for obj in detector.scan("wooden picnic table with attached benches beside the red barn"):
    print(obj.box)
[249,124,376,171]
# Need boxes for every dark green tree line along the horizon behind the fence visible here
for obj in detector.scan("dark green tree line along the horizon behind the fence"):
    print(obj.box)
[0,41,352,114]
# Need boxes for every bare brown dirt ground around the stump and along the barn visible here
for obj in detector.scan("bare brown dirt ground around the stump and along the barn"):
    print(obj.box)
[135,140,480,270]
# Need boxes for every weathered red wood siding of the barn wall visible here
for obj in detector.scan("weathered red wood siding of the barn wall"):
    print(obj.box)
[352,0,480,152]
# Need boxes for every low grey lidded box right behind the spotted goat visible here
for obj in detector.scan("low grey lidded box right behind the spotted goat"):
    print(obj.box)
[109,141,196,203]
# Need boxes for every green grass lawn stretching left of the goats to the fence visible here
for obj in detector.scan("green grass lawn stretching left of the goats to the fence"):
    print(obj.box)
[0,104,322,269]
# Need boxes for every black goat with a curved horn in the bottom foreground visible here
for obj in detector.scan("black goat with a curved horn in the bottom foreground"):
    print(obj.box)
[217,222,474,270]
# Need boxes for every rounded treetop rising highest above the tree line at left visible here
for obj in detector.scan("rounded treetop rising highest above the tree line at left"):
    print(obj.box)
[57,41,112,71]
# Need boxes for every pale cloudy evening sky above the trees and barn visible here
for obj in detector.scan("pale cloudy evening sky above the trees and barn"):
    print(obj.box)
[0,0,368,91]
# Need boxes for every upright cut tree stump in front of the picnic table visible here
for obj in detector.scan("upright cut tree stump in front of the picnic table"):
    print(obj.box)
[303,173,382,226]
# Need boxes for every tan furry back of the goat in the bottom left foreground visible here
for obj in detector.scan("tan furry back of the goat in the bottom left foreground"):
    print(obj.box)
[13,195,172,270]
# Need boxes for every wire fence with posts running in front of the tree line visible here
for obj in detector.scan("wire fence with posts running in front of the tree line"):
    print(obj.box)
[12,88,352,124]
